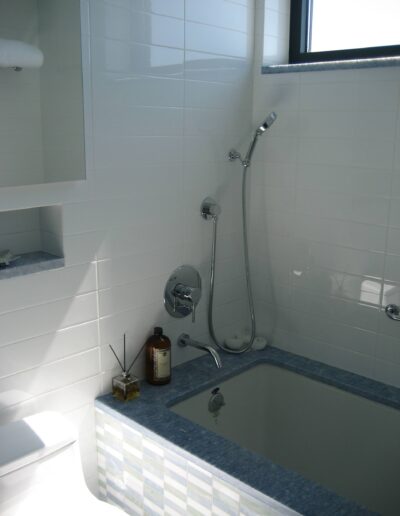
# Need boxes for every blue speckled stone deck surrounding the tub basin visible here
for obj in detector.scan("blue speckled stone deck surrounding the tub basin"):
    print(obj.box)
[96,347,400,516]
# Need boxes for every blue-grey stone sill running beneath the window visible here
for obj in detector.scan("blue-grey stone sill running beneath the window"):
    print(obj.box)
[261,57,400,74]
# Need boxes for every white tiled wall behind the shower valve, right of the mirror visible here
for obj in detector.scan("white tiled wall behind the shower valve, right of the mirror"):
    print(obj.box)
[0,0,254,494]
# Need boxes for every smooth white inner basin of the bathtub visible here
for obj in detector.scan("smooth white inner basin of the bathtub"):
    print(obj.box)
[170,364,400,516]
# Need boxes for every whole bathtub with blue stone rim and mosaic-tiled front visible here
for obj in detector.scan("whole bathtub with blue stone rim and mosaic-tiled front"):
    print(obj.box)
[96,348,400,516]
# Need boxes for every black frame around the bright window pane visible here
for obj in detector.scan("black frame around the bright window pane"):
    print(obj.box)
[289,0,400,64]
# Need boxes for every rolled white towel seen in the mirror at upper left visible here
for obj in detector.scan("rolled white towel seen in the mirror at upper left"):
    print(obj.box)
[0,38,44,69]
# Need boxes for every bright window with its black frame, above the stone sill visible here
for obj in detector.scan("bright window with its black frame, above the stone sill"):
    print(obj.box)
[289,0,400,63]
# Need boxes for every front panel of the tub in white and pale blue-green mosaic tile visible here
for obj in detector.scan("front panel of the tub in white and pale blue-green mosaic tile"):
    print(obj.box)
[96,408,297,516]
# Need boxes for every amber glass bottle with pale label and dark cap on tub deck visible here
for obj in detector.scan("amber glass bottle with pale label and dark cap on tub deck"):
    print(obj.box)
[146,326,171,385]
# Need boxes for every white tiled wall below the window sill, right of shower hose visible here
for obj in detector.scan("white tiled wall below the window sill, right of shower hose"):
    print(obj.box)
[251,8,400,386]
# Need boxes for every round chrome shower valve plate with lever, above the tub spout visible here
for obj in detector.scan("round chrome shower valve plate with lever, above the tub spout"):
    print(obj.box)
[164,265,201,322]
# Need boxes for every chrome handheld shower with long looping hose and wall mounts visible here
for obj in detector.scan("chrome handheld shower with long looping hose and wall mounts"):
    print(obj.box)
[205,112,277,354]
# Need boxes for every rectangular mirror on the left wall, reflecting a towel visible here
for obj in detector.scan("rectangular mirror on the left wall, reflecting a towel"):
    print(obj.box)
[0,0,86,187]
